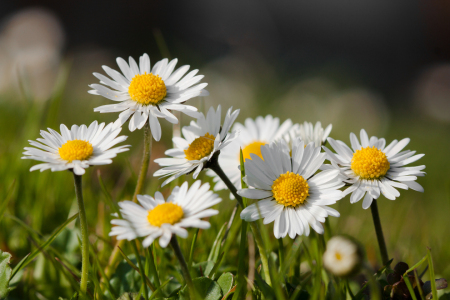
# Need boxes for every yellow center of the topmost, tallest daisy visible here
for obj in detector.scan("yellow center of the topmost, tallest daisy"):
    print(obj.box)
[128,72,167,105]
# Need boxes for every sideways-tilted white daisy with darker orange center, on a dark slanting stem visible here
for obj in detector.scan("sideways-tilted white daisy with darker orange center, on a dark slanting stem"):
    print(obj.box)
[153,105,239,186]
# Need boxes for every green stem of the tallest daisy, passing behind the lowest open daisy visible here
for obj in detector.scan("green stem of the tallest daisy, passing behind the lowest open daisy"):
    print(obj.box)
[105,122,152,280]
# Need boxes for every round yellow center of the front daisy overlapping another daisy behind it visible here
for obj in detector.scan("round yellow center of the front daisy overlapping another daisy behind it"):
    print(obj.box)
[272,172,309,207]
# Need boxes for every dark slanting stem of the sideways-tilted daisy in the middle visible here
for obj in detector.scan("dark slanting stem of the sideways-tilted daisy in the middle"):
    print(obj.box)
[209,160,272,286]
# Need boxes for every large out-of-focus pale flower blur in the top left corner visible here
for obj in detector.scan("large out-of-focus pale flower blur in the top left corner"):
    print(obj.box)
[0,8,64,101]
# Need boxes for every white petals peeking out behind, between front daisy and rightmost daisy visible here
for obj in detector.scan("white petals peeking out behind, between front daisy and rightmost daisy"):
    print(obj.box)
[284,122,333,147]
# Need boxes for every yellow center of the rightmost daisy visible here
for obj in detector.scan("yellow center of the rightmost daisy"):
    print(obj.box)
[351,146,390,179]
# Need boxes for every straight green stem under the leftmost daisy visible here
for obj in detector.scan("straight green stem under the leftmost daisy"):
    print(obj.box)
[73,173,89,298]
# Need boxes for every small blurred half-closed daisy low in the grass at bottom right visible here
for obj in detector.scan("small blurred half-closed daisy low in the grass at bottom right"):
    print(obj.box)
[323,236,362,276]
